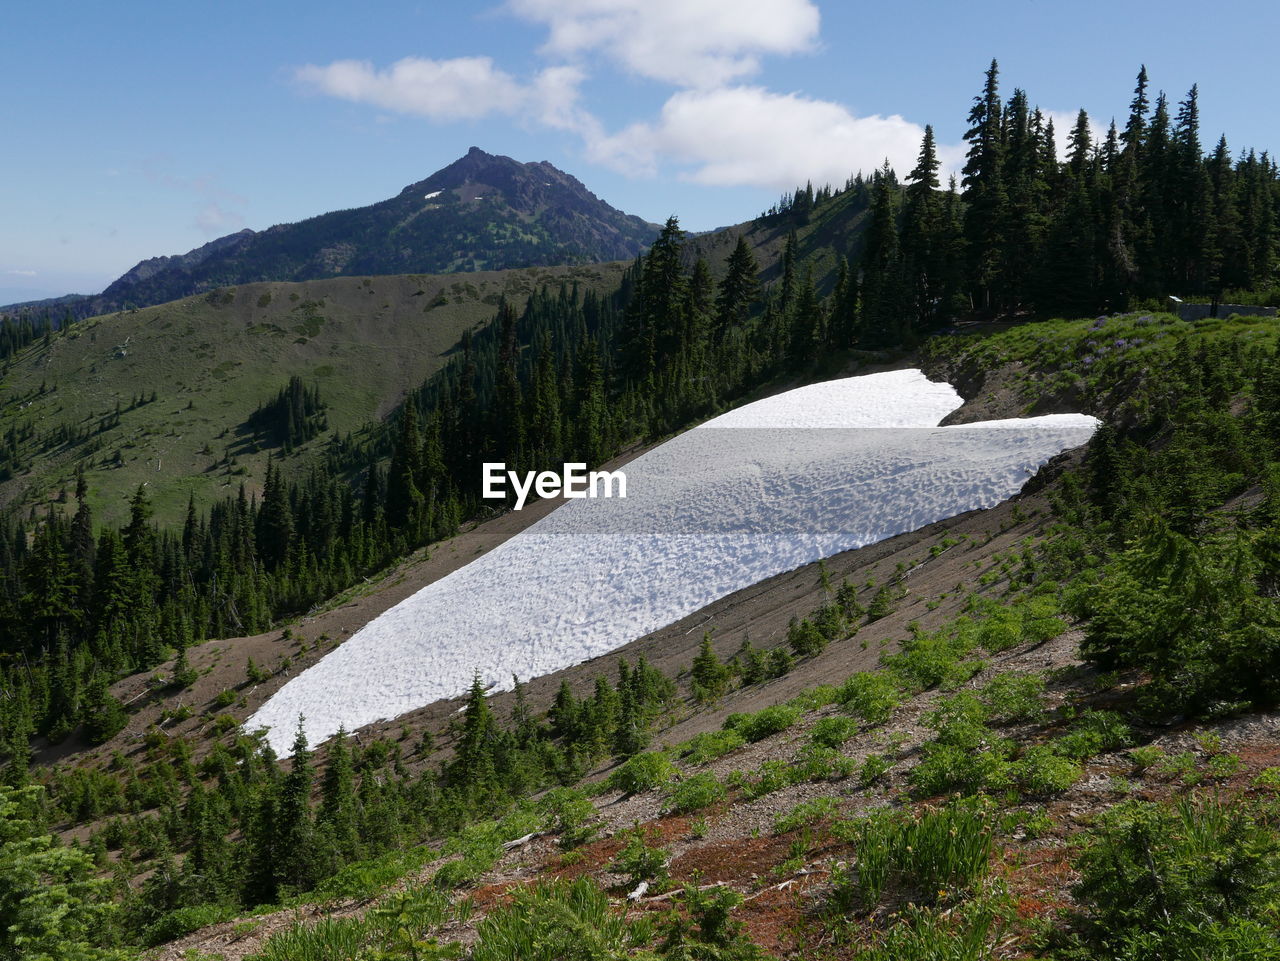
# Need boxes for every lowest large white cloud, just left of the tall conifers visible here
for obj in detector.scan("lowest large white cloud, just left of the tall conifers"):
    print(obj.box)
[588,87,961,189]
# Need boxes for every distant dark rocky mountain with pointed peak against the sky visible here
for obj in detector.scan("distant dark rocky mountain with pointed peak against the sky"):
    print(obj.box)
[0,147,657,317]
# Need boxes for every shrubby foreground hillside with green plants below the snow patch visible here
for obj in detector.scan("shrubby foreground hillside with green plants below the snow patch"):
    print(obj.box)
[7,315,1280,958]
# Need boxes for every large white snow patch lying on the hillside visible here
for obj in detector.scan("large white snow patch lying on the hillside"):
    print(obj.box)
[247,370,1098,754]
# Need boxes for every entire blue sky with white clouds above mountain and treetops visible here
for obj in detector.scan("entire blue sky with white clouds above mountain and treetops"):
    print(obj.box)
[0,0,1280,303]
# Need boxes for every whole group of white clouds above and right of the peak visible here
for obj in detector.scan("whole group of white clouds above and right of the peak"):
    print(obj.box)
[294,0,964,189]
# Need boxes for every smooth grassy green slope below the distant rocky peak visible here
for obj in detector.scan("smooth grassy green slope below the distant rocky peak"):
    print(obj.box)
[0,264,623,521]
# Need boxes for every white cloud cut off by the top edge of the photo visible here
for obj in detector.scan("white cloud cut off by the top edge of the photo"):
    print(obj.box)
[508,0,819,87]
